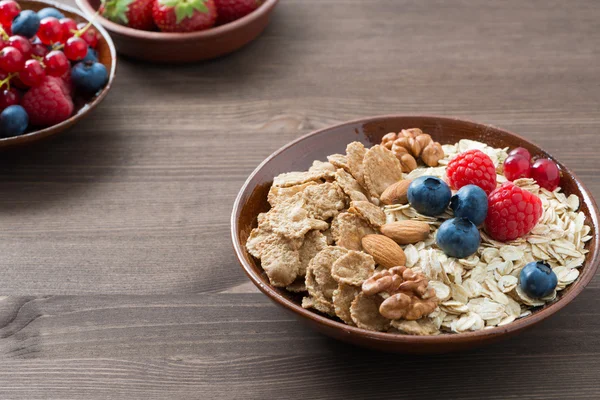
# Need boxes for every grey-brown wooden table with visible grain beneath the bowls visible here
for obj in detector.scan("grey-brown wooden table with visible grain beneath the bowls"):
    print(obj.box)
[0,0,600,400]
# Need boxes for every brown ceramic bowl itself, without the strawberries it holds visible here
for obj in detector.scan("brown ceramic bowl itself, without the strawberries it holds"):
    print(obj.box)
[76,0,279,63]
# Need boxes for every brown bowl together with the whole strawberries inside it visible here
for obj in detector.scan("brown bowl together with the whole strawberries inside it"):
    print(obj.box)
[76,0,279,63]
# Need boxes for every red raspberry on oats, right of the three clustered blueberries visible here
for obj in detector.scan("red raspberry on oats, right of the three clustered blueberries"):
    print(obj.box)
[485,182,542,242]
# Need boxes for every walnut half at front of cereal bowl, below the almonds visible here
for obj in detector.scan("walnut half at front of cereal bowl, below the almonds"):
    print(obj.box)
[362,267,439,321]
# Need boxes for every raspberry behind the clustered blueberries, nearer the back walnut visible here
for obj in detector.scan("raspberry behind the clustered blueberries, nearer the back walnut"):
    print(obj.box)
[446,150,496,194]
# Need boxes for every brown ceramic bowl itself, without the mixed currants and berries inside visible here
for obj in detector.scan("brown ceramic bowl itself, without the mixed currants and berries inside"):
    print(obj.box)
[0,0,117,149]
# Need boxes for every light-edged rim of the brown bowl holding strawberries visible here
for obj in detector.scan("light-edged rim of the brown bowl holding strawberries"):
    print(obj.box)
[75,0,279,42]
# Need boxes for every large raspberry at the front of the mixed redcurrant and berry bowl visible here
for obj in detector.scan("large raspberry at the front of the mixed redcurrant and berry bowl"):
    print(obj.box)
[21,76,73,126]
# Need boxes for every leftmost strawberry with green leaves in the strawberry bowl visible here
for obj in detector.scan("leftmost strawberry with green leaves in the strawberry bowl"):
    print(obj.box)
[100,0,155,31]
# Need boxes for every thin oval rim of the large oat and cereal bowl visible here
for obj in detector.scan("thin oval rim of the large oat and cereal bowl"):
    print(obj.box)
[230,114,600,345]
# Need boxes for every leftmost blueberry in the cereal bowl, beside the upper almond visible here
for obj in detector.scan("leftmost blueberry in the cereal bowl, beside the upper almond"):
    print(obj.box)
[408,176,452,217]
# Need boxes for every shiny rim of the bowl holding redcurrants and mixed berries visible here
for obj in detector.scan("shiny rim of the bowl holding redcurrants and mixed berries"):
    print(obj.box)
[0,0,117,147]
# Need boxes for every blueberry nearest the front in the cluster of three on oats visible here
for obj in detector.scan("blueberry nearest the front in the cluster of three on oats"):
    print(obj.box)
[436,218,480,258]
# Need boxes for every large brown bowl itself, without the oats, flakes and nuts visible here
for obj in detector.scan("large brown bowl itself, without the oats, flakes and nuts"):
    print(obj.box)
[231,115,600,353]
